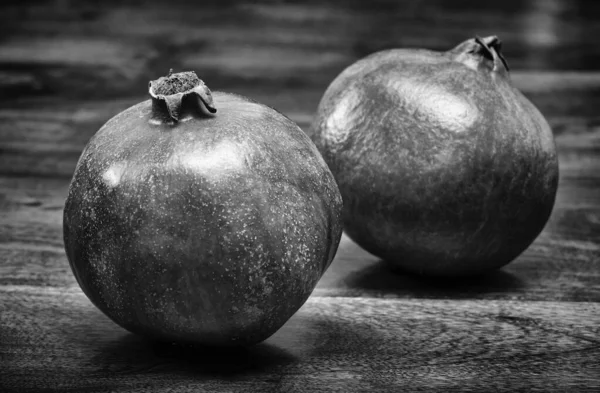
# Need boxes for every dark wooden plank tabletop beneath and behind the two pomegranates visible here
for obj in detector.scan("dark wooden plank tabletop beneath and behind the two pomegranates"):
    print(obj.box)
[0,0,600,392]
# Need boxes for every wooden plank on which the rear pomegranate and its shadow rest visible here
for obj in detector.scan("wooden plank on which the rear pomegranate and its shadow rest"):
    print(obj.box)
[0,170,600,301]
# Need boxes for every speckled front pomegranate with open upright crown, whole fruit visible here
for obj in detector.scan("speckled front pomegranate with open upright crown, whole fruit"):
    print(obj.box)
[64,72,342,346]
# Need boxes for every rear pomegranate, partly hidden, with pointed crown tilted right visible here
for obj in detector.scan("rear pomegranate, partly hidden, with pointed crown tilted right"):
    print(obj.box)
[309,37,558,276]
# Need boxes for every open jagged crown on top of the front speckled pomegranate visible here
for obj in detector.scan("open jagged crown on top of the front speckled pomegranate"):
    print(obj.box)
[148,69,217,123]
